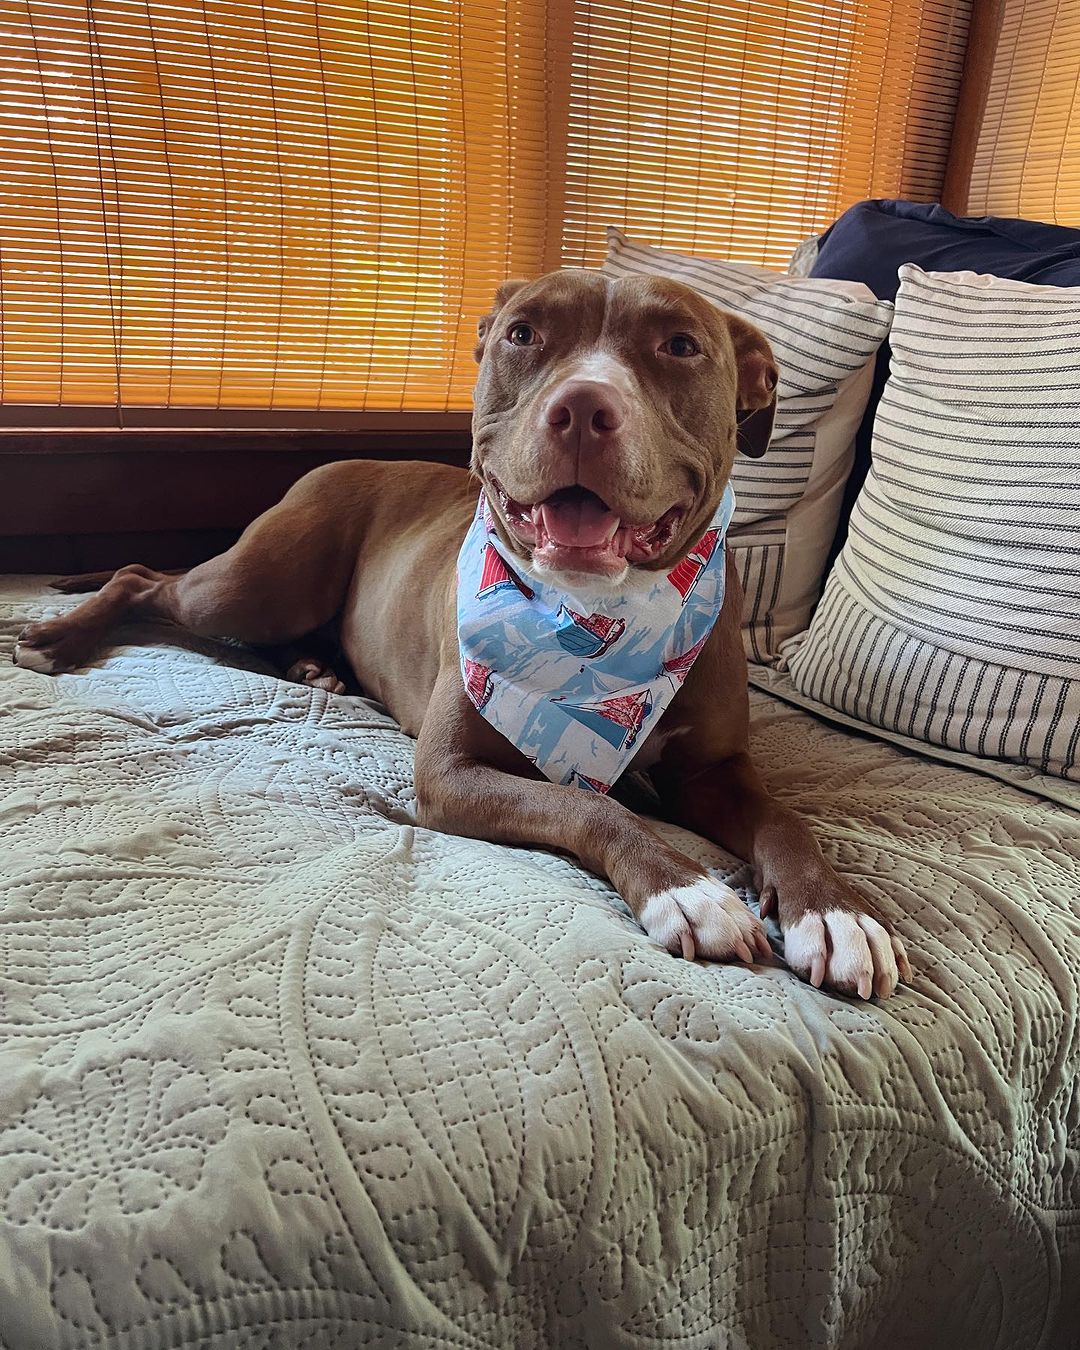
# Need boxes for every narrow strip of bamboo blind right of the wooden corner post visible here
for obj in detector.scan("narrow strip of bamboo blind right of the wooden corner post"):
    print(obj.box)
[968,0,1080,225]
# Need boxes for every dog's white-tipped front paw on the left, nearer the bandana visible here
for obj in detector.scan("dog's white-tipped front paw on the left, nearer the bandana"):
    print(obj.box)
[639,876,771,961]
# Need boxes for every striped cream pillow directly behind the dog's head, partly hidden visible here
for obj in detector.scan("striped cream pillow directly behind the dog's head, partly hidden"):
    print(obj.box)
[603,230,892,663]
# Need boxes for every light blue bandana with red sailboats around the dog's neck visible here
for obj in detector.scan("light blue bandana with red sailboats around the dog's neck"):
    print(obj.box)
[458,483,734,792]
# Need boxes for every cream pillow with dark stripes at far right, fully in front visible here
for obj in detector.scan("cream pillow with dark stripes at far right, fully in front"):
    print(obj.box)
[786,263,1080,779]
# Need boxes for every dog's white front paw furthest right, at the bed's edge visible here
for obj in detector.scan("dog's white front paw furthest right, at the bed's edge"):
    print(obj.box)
[784,910,911,999]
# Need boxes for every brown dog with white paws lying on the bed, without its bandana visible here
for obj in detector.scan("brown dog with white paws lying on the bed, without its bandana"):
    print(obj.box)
[16,271,911,998]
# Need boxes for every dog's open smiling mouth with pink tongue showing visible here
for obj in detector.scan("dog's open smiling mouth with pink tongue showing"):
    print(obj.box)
[493,481,686,576]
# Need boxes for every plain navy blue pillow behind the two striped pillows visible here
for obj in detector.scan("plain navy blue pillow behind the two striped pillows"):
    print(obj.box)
[810,201,1080,566]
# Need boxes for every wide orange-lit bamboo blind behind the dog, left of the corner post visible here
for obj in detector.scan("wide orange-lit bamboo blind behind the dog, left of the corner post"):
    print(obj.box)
[0,0,969,420]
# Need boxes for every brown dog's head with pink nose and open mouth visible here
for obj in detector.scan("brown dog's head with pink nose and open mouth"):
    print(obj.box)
[473,270,776,585]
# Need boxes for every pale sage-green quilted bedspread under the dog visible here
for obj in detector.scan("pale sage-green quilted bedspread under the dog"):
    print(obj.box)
[0,585,1080,1350]
